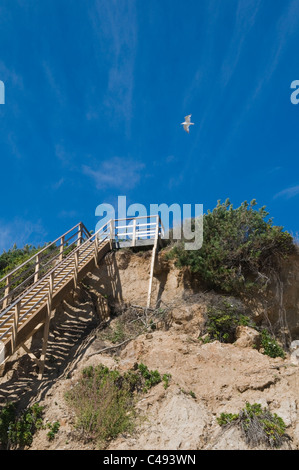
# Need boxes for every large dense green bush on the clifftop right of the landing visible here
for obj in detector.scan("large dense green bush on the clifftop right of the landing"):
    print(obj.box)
[166,200,295,294]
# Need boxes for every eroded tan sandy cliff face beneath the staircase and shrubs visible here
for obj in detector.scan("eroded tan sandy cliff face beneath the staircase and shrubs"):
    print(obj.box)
[0,250,299,450]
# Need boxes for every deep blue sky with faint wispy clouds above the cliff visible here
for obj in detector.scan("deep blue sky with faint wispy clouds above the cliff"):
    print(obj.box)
[0,0,299,252]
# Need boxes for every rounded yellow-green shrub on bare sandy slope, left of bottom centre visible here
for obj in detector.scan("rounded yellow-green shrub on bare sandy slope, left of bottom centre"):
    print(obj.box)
[66,363,170,448]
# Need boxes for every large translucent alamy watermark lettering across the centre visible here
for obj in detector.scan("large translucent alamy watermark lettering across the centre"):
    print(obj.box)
[95,196,203,250]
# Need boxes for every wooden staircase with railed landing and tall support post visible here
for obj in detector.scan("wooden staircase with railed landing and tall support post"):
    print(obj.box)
[0,216,163,378]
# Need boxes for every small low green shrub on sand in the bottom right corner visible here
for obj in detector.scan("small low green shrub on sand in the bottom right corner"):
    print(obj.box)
[217,402,290,448]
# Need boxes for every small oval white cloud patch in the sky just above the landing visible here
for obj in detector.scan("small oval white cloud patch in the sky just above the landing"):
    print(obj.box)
[82,157,145,191]
